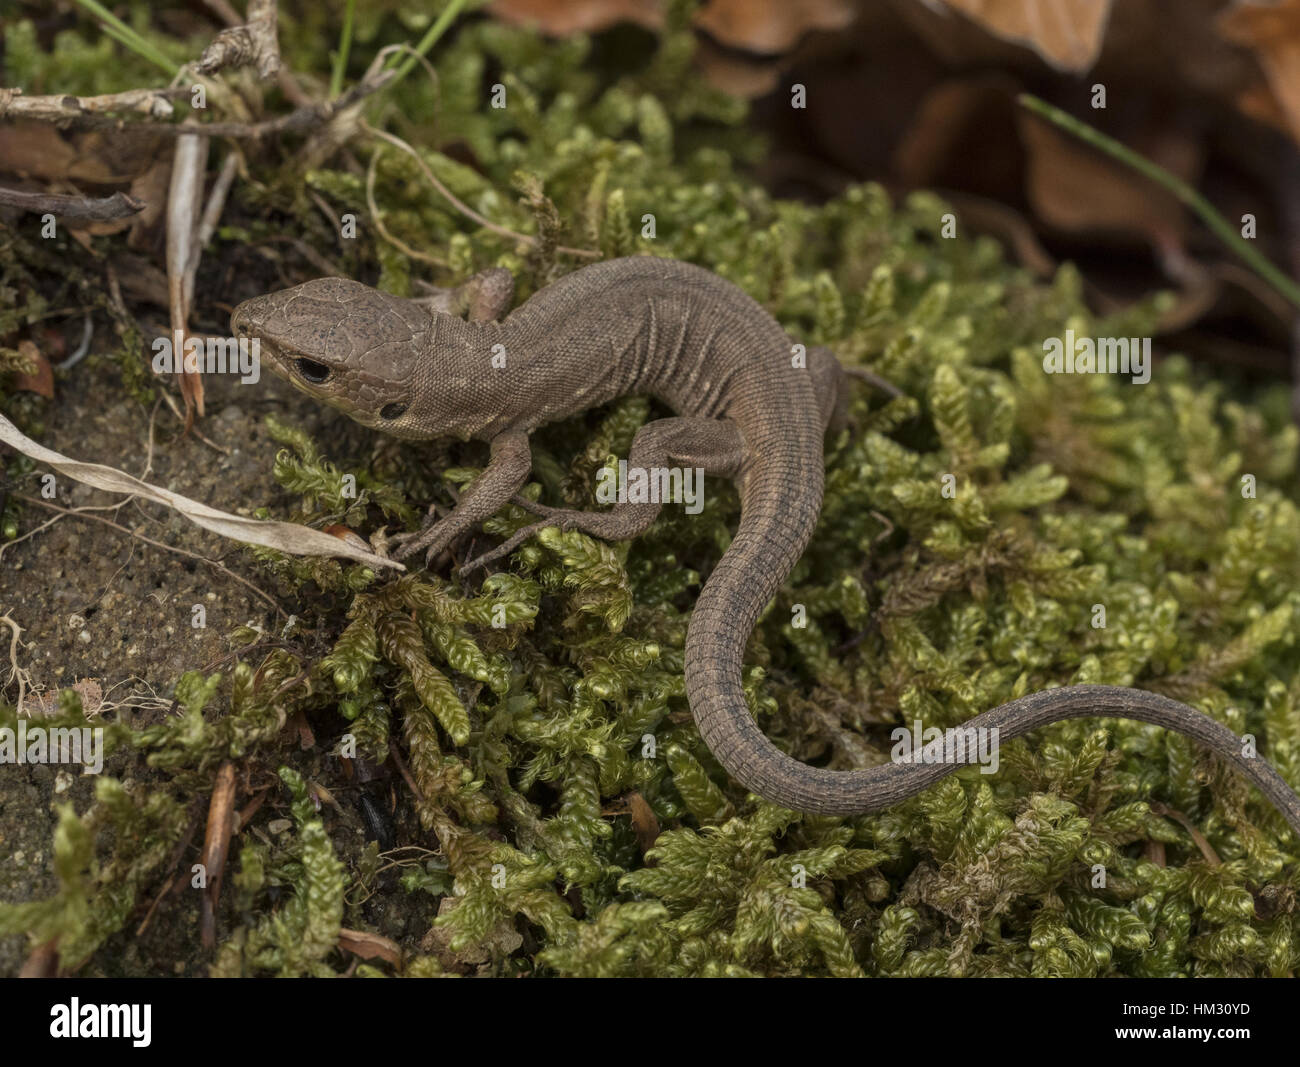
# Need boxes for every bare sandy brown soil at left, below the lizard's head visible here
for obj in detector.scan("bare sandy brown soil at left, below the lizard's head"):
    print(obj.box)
[0,350,390,975]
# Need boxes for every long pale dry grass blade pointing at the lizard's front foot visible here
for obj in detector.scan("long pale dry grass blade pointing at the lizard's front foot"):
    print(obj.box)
[0,415,406,571]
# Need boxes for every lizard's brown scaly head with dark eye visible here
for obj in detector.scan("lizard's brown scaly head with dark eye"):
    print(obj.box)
[230,278,434,437]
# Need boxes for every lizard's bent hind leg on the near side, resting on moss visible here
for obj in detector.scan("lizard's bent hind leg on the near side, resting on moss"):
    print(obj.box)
[460,416,745,573]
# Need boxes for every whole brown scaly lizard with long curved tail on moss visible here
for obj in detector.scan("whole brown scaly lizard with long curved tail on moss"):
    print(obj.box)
[231,257,1300,836]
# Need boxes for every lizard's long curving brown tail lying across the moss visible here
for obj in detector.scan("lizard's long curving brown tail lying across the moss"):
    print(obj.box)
[686,460,1300,838]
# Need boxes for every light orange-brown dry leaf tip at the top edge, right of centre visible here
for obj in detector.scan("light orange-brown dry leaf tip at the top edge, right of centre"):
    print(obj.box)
[943,0,1112,73]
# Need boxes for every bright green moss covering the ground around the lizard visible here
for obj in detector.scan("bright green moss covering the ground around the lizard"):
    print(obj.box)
[0,5,1300,976]
